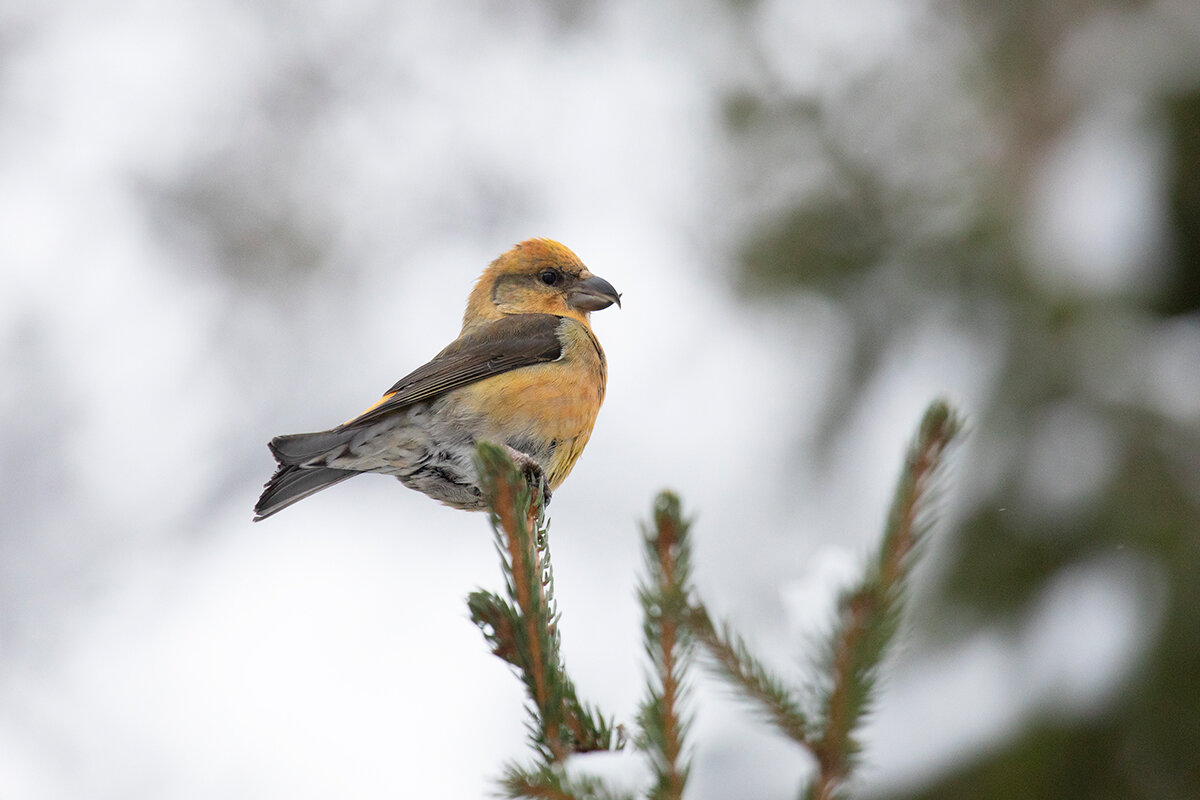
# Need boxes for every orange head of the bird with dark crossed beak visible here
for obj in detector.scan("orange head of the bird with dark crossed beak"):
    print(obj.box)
[463,239,620,331]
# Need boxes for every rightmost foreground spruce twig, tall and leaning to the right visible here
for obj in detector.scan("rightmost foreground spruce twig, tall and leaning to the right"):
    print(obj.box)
[806,402,961,800]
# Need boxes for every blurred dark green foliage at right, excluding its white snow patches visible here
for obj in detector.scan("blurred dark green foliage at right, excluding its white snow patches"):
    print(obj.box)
[724,0,1200,800]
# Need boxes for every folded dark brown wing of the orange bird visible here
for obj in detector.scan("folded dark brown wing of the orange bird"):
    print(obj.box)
[342,314,563,427]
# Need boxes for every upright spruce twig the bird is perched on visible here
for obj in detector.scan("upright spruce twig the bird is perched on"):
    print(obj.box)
[467,444,624,777]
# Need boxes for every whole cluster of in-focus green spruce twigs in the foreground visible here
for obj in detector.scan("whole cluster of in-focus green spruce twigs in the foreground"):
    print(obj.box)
[468,402,960,800]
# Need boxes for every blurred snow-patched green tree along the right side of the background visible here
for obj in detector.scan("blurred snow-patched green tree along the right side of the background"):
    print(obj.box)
[724,0,1200,800]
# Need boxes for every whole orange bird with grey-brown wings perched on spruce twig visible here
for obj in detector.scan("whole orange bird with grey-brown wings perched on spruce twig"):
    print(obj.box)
[254,239,620,522]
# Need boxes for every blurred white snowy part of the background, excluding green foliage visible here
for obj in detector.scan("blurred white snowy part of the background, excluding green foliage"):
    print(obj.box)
[0,0,1196,800]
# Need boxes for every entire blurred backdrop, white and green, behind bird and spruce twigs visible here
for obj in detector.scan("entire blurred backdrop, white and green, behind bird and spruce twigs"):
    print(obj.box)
[0,0,1200,800]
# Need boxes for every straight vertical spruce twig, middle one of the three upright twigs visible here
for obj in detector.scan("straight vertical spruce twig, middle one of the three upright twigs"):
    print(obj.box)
[637,492,692,800]
